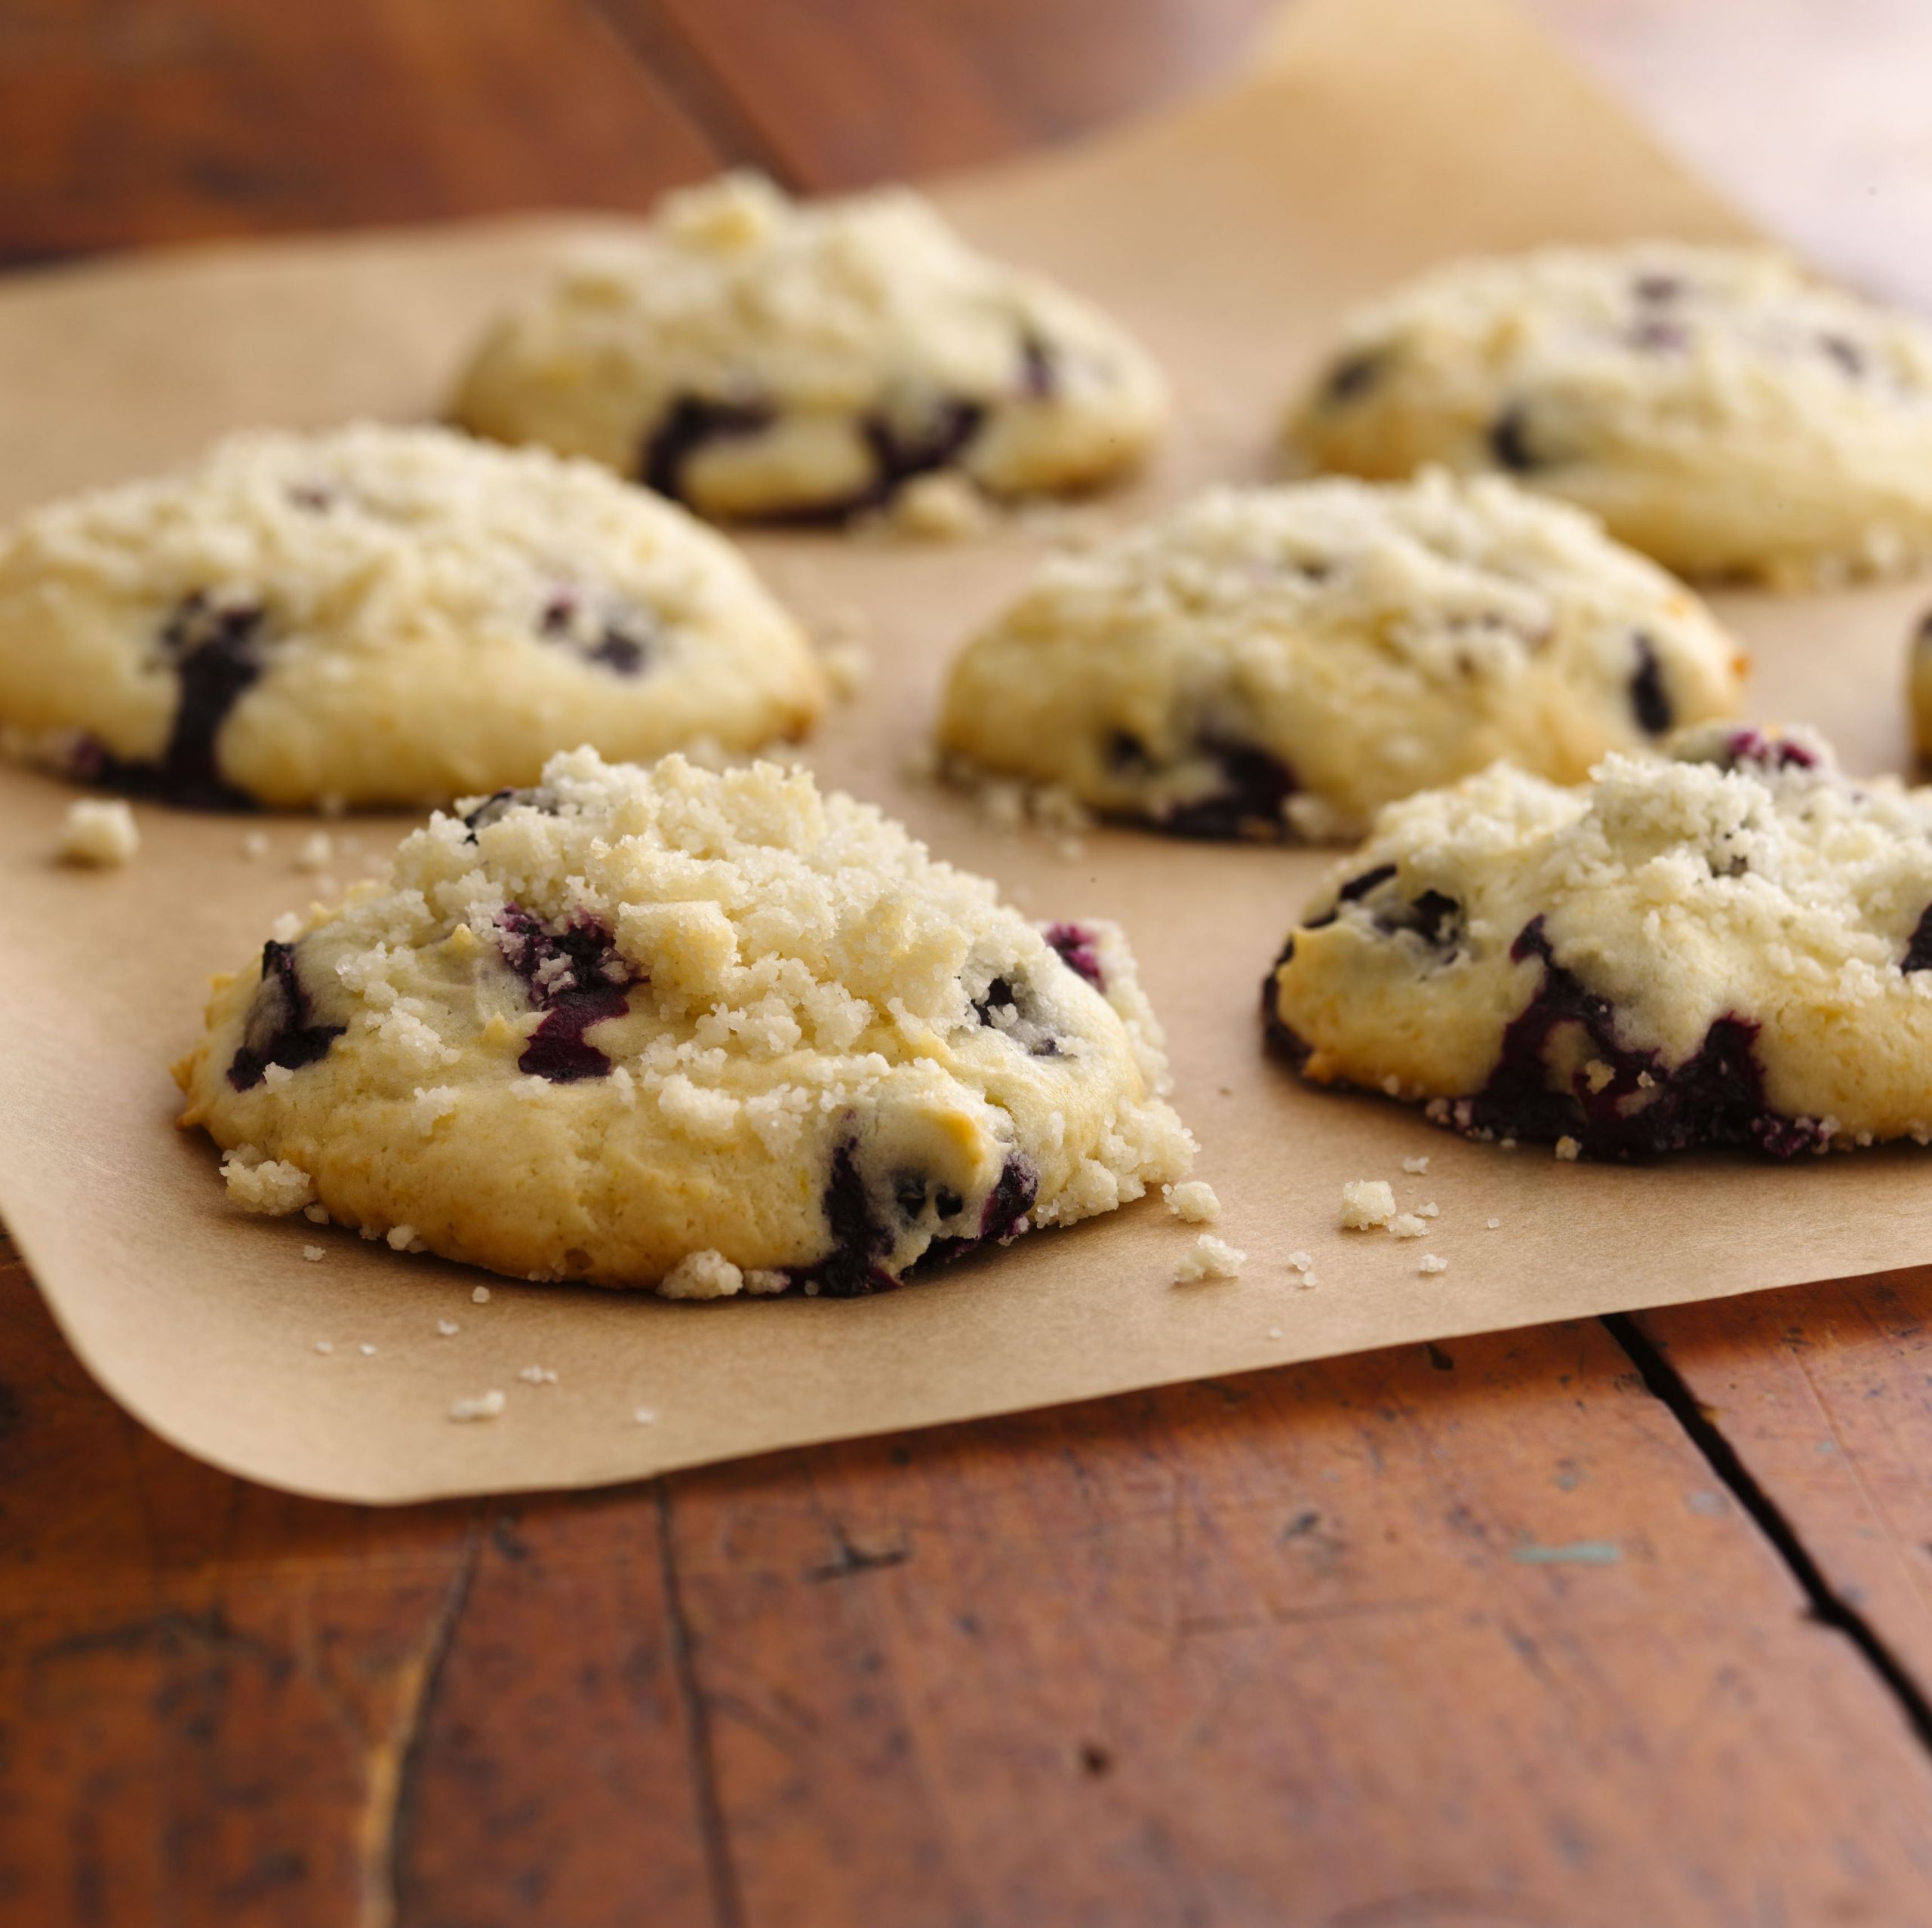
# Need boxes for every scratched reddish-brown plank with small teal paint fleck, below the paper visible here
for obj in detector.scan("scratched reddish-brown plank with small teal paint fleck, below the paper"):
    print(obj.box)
[672,1324,1932,1928]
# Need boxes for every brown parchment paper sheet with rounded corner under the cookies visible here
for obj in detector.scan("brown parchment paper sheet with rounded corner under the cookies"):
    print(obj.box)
[0,0,1932,1501]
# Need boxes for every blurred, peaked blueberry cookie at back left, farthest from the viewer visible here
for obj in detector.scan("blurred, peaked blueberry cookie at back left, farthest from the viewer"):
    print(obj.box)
[454,174,1167,520]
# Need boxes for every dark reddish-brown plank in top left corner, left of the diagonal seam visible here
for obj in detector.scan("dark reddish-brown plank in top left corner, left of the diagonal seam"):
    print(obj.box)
[0,0,722,261]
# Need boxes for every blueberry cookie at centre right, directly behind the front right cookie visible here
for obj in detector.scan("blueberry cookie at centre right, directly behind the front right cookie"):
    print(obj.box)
[939,469,1743,837]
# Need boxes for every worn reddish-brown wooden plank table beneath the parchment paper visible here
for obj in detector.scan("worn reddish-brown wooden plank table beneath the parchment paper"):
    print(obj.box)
[11,0,1932,1928]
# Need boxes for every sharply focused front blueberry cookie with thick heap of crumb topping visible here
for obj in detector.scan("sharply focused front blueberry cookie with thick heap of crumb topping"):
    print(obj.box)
[176,749,1194,1296]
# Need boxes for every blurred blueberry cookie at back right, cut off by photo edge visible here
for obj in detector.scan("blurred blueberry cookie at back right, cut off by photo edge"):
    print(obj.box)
[1289,241,1932,586]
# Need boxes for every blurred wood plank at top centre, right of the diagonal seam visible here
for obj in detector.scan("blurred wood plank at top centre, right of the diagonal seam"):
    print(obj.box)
[618,0,1279,191]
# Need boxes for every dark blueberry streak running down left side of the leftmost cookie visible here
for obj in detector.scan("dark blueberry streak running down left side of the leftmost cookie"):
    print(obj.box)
[88,589,269,810]
